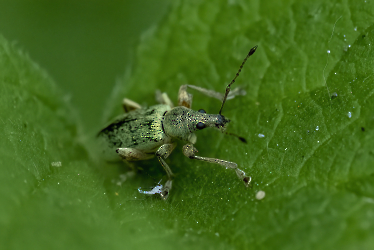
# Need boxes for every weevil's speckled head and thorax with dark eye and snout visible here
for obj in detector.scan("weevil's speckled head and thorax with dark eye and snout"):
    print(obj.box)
[163,106,230,143]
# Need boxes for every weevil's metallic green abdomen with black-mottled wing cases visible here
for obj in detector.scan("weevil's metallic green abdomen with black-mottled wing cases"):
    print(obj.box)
[98,104,171,160]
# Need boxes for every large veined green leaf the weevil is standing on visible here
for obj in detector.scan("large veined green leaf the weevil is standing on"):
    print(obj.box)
[0,1,374,249]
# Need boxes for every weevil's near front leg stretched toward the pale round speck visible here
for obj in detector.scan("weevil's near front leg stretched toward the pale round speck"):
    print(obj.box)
[183,144,251,187]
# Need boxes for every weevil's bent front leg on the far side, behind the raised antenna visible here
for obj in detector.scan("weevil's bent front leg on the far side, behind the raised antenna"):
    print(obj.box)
[178,84,247,108]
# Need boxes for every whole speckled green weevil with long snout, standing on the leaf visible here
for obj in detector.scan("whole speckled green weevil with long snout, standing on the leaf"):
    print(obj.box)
[98,46,257,200]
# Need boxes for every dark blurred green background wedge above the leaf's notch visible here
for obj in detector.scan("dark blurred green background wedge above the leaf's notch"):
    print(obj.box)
[0,0,170,133]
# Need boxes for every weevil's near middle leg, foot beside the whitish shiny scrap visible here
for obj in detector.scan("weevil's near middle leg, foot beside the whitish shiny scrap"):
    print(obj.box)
[156,143,177,200]
